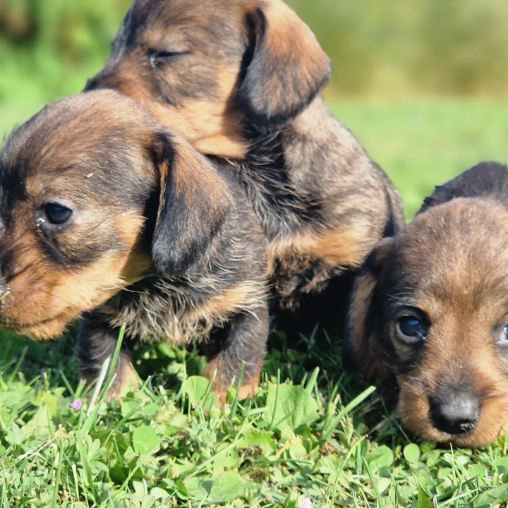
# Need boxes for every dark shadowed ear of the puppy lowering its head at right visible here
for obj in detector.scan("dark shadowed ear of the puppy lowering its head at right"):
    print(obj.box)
[345,238,393,380]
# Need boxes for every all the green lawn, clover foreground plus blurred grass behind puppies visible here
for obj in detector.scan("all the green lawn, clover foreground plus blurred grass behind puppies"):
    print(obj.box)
[0,99,508,508]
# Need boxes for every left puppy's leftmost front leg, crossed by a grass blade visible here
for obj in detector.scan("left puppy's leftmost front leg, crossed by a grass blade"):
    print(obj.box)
[76,313,139,398]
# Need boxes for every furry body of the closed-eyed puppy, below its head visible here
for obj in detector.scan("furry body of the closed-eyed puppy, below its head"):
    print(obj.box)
[241,99,403,310]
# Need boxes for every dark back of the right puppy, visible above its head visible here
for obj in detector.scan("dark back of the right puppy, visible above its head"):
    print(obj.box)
[418,162,508,214]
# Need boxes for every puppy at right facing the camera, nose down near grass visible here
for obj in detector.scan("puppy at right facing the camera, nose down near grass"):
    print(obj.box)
[349,163,508,447]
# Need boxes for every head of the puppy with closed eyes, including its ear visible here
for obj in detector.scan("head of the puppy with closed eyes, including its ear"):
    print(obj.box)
[87,0,330,157]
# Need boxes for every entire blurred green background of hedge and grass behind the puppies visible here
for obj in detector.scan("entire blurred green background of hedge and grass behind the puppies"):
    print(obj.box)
[0,0,508,214]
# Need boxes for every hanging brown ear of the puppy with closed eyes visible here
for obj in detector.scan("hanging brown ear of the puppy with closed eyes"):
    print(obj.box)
[239,0,330,129]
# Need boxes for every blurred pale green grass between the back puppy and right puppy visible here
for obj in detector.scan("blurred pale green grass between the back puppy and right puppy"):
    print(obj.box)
[334,99,508,217]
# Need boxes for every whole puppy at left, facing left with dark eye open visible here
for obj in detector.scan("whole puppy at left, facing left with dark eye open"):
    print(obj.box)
[0,91,268,400]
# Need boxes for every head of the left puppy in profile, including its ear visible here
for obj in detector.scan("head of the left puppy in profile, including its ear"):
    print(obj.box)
[0,91,230,338]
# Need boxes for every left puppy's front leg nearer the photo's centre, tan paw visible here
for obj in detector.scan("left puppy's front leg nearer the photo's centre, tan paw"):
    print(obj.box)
[205,302,268,404]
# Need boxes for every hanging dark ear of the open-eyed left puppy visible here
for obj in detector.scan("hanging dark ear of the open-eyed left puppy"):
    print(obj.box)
[152,134,232,277]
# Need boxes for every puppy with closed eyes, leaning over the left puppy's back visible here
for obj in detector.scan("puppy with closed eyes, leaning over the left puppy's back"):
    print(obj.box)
[87,0,402,318]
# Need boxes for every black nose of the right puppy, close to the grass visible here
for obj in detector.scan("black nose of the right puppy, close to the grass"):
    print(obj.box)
[430,389,480,434]
